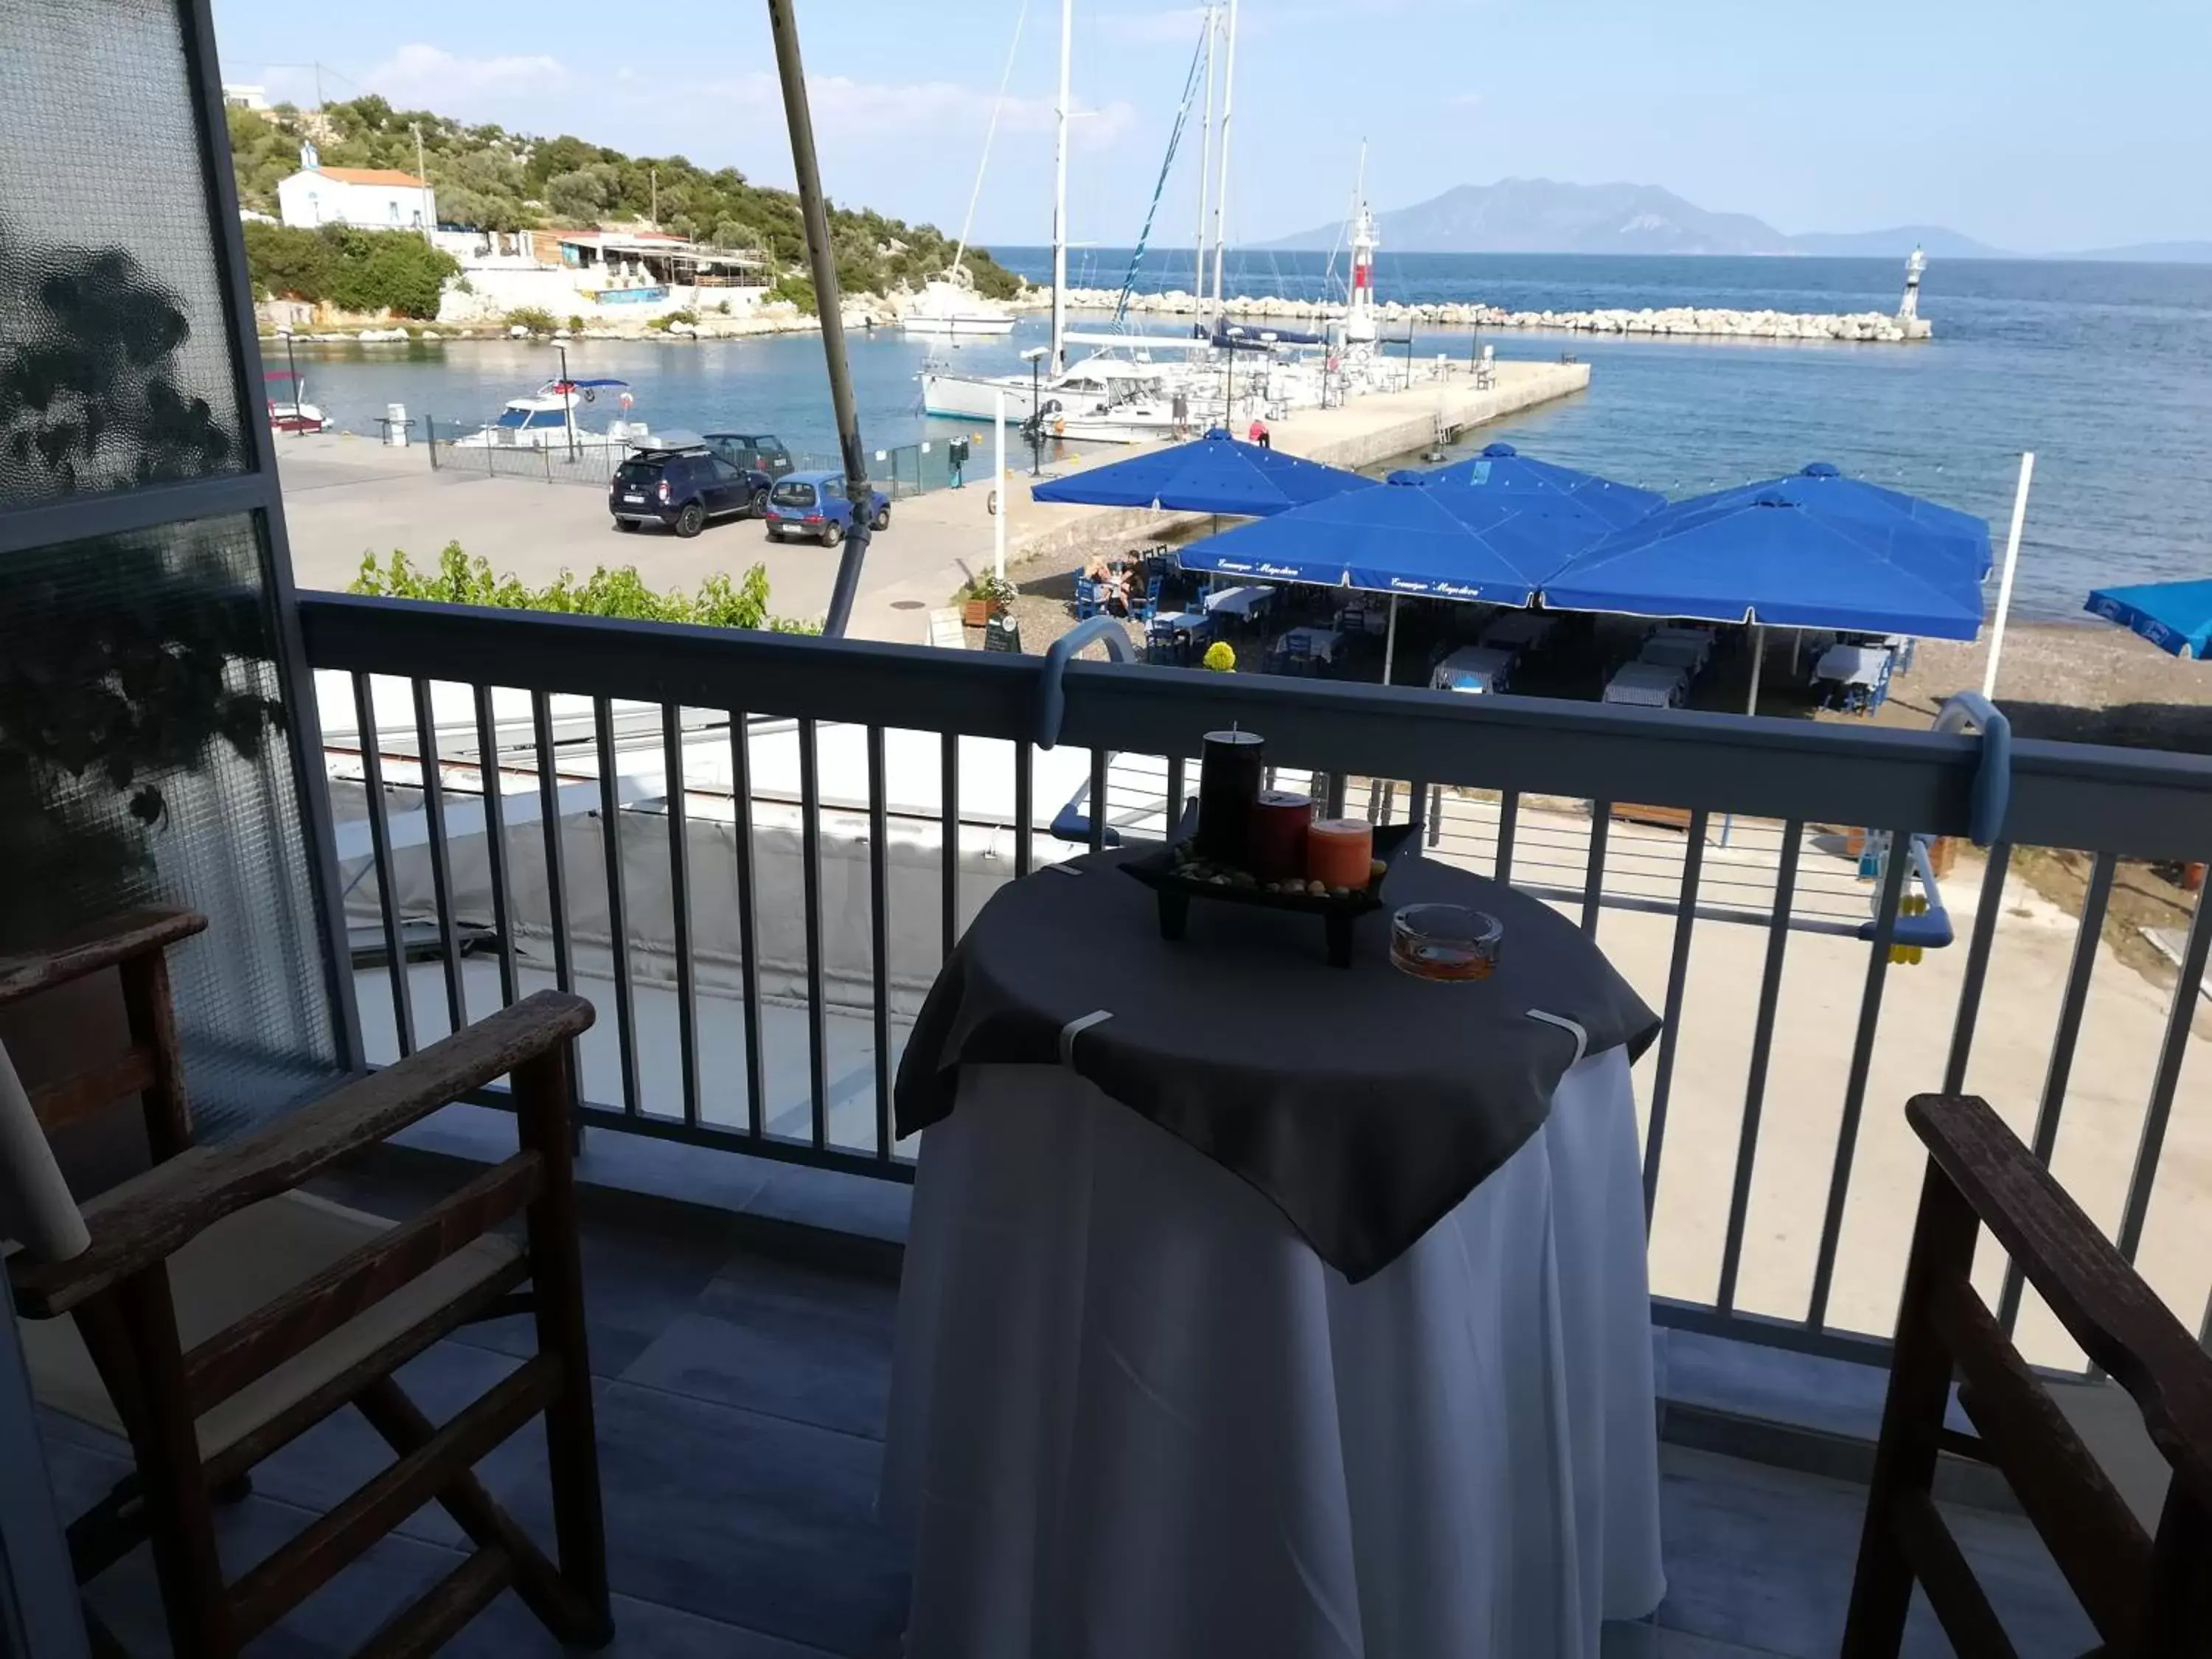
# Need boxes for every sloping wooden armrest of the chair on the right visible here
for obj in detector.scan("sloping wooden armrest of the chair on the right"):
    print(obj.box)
[1905,1095,2212,1506]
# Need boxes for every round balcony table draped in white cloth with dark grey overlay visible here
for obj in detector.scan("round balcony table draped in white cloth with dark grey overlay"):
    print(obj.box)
[880,852,1666,1659]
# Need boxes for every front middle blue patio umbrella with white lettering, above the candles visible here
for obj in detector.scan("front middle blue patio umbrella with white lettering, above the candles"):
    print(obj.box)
[1179,473,1606,679]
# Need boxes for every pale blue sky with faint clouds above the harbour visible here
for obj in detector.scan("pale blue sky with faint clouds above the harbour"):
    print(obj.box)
[215,0,2212,252]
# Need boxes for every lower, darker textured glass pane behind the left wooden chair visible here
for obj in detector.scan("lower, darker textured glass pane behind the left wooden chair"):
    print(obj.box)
[0,515,336,1135]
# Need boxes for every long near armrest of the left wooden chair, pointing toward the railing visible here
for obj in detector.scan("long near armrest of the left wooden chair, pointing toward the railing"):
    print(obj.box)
[11,991,593,1318]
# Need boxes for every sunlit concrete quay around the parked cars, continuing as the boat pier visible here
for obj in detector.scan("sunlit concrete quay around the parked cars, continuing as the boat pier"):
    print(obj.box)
[276,361,1590,644]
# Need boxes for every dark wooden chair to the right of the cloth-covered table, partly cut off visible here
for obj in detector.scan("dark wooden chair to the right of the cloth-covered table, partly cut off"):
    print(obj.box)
[1843,1095,2212,1659]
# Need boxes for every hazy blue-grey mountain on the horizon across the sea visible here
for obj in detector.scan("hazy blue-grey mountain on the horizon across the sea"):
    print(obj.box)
[1267,179,2002,259]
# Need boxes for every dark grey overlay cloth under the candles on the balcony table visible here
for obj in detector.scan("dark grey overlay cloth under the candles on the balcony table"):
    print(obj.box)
[894,847,1659,1283]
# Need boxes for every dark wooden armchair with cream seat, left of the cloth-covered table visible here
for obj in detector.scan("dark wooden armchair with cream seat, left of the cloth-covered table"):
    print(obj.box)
[0,911,613,1659]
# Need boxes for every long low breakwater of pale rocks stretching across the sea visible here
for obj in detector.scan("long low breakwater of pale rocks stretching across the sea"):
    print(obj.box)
[1015,288,1931,345]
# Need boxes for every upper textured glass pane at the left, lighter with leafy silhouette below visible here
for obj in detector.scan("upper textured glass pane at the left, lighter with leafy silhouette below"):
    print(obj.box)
[0,0,246,507]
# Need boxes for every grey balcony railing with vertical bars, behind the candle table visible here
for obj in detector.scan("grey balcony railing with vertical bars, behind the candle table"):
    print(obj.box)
[299,595,2212,1363]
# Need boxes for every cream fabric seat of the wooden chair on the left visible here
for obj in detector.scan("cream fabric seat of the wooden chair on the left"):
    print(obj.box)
[20,1192,522,1458]
